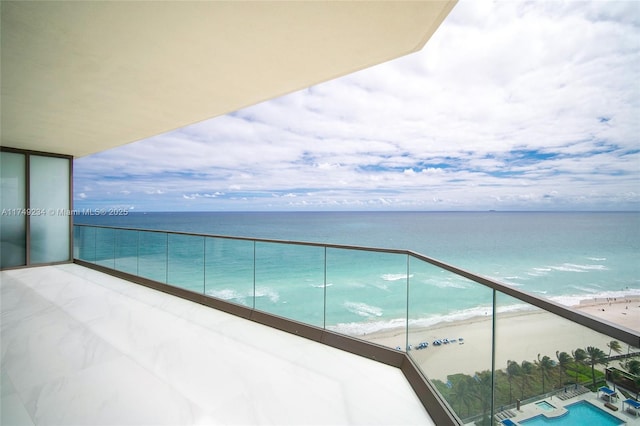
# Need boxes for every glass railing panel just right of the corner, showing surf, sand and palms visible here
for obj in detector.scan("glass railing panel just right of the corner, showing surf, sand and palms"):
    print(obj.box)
[407,258,493,424]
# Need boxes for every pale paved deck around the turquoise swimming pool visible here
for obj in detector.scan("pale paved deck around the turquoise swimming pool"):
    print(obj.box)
[510,392,640,425]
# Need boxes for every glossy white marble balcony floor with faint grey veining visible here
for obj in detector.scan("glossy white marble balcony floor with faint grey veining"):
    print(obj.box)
[0,264,434,425]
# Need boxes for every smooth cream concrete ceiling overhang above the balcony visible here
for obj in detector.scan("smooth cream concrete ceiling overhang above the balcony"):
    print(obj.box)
[0,0,455,156]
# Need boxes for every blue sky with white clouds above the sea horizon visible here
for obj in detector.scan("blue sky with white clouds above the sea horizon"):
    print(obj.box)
[74,0,640,211]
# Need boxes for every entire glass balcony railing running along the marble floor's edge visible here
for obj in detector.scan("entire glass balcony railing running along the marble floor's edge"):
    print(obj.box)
[74,225,640,425]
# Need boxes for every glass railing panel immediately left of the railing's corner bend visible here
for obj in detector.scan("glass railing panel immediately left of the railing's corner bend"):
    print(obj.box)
[326,248,407,348]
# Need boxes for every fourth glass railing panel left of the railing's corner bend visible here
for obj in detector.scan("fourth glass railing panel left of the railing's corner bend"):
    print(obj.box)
[167,234,204,293]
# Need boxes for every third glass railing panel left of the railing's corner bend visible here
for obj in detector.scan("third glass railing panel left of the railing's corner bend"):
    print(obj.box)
[205,237,254,308]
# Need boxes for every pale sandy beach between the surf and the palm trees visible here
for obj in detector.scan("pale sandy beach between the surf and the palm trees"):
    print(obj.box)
[365,296,640,380]
